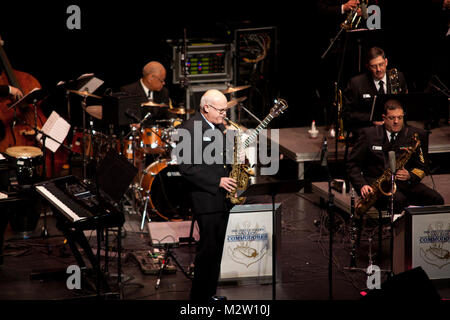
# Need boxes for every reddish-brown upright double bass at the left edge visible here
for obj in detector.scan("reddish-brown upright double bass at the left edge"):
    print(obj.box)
[0,37,66,178]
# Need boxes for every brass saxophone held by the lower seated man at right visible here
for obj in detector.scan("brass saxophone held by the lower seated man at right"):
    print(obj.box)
[355,133,420,218]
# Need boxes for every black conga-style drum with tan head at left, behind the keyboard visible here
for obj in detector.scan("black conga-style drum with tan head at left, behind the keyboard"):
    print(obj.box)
[5,146,43,185]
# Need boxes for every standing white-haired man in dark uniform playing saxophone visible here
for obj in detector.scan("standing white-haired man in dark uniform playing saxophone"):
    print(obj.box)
[177,89,237,302]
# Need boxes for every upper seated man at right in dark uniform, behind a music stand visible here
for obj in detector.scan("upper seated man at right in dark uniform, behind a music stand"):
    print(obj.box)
[343,47,408,139]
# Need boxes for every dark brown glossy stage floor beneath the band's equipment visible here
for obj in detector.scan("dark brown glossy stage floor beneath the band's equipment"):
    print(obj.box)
[0,193,450,301]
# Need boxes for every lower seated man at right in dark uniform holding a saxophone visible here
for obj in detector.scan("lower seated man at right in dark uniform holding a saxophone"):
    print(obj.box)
[346,99,444,214]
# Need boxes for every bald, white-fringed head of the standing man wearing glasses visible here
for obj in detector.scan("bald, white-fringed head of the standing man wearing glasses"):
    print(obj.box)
[200,89,228,124]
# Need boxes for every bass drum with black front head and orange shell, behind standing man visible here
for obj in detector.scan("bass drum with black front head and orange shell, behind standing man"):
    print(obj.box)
[140,159,192,221]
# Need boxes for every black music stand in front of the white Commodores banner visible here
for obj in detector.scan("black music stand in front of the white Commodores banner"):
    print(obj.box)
[239,179,305,300]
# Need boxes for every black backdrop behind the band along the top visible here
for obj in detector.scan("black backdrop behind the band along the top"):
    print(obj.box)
[0,1,449,127]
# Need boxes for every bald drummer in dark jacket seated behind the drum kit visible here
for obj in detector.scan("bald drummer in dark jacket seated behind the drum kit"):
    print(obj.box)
[120,61,170,122]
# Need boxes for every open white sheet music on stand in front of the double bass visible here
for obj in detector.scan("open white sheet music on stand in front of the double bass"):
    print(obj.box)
[36,111,70,152]
